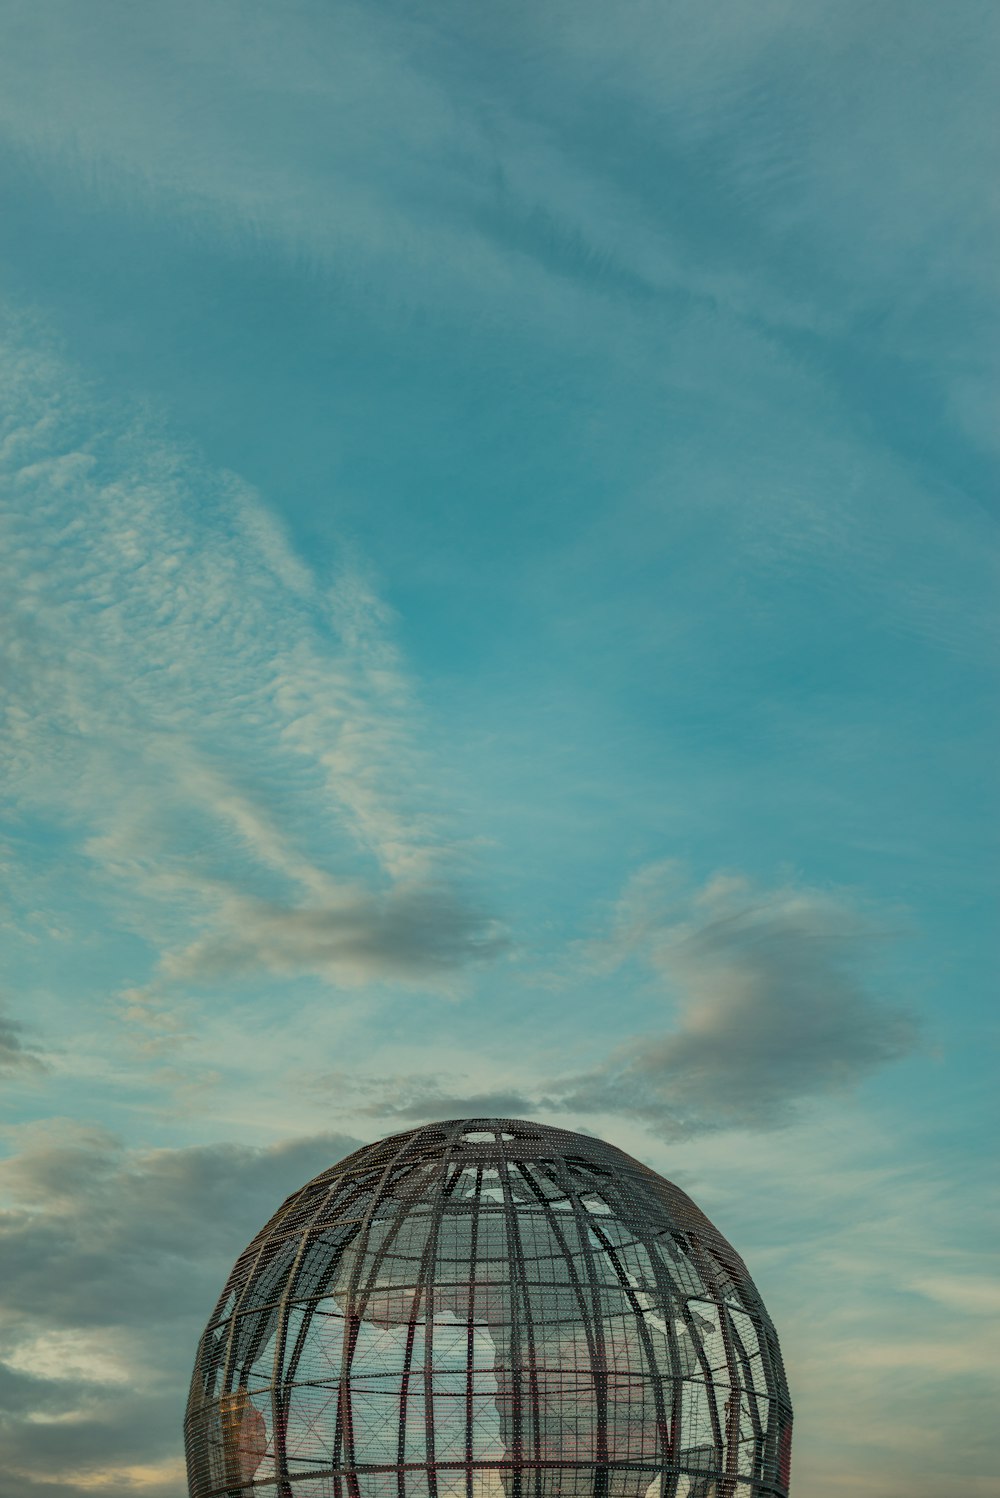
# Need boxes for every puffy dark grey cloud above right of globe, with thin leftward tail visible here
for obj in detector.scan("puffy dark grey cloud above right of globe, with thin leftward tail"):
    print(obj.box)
[367,863,918,1137]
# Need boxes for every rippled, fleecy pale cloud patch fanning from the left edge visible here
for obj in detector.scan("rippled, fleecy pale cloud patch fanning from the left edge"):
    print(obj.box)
[0,320,503,1012]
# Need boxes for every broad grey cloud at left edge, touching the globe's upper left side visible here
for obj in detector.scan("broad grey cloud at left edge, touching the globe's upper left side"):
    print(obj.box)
[0,1121,356,1335]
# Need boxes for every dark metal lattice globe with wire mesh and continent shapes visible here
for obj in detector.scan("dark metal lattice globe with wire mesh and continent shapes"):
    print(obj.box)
[186,1119,792,1498]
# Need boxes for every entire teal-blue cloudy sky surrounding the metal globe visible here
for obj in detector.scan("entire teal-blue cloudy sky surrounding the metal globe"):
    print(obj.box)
[0,0,1000,1498]
